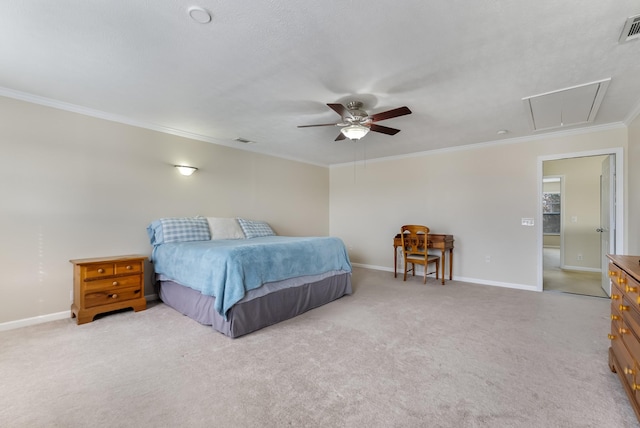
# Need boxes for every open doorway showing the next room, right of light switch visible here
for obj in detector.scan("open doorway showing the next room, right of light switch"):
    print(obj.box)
[538,150,622,297]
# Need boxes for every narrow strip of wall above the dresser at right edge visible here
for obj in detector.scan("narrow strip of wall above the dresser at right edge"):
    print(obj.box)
[626,115,640,255]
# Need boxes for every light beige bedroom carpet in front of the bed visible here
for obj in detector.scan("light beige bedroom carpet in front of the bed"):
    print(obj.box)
[0,268,638,428]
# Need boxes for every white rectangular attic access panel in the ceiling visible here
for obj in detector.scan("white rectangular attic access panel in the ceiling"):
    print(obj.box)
[522,78,611,131]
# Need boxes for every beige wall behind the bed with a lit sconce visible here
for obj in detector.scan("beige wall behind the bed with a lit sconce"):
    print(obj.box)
[0,97,329,324]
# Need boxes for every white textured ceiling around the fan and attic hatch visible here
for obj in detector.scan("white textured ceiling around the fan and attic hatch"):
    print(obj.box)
[0,0,640,165]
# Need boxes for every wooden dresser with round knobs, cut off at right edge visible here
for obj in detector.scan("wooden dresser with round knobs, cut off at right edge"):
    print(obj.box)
[607,255,640,420]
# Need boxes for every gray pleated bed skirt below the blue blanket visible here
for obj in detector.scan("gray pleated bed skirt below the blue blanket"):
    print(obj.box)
[158,272,352,338]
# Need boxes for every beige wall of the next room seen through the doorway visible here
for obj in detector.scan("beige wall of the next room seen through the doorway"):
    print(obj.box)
[543,156,607,270]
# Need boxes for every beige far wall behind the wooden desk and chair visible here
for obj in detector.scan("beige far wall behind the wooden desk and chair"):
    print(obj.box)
[330,127,627,289]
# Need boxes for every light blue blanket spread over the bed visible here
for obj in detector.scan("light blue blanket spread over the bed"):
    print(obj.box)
[151,236,351,319]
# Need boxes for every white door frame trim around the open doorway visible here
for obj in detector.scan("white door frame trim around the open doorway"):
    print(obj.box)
[535,147,625,291]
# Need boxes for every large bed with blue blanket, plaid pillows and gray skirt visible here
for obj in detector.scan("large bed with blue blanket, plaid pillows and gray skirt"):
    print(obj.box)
[147,217,352,338]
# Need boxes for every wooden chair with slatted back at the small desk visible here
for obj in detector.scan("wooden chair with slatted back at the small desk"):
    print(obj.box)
[400,224,440,284]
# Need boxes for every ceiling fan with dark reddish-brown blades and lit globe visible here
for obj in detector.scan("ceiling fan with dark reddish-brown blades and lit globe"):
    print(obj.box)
[298,101,411,141]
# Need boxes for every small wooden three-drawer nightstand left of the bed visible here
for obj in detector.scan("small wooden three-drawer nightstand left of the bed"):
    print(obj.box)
[69,255,147,324]
